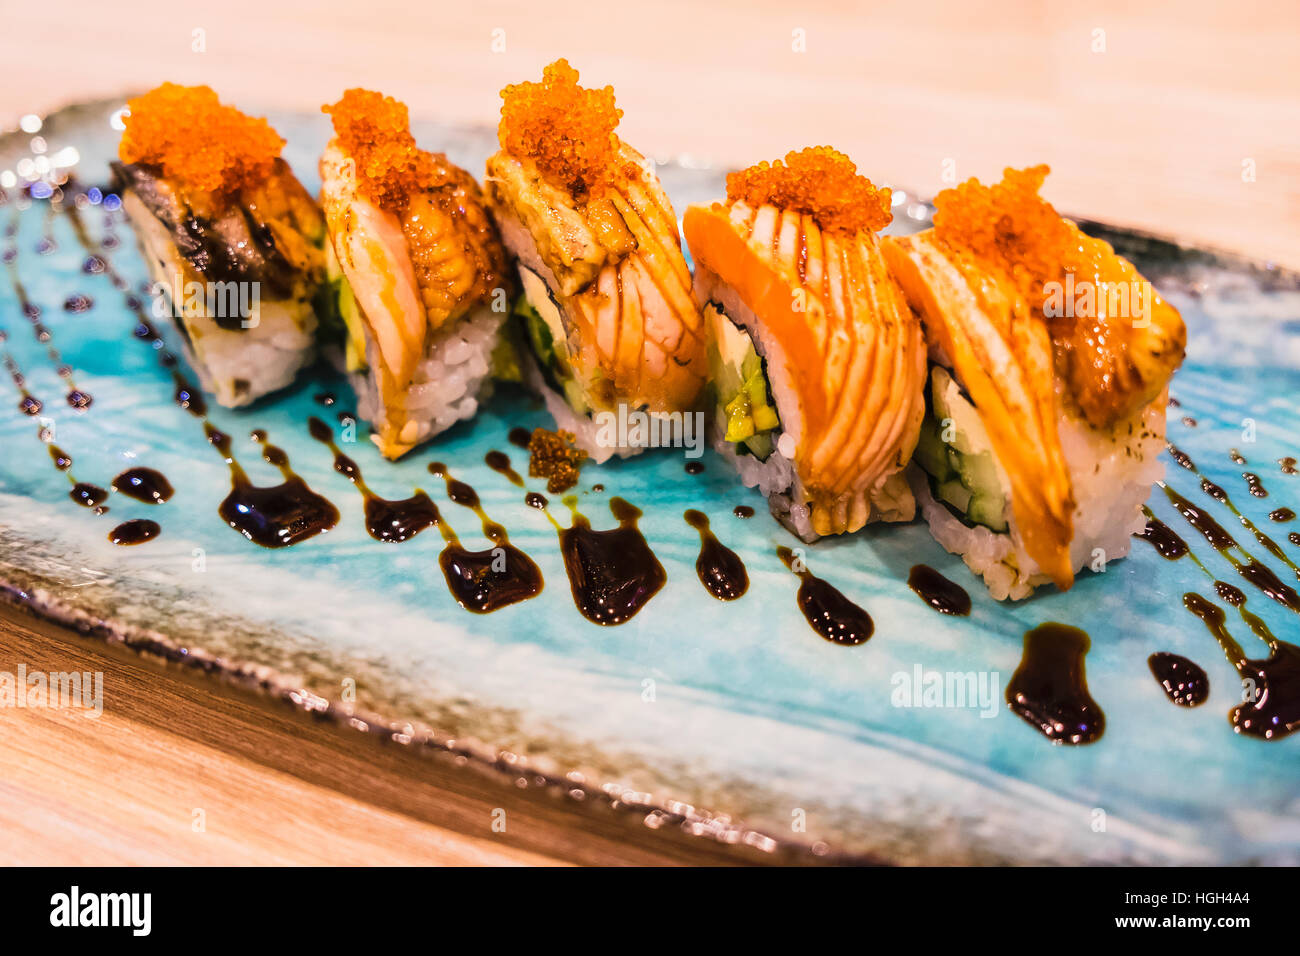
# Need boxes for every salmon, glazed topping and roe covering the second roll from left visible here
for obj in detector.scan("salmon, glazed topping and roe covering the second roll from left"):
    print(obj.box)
[321,88,512,458]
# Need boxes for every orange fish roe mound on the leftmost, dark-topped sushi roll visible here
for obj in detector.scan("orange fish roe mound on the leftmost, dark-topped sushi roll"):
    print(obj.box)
[117,83,285,194]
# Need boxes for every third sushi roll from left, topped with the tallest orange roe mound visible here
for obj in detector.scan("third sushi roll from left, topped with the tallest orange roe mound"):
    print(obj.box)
[485,60,706,462]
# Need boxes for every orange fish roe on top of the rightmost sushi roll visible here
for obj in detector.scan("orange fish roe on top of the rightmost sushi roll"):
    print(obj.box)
[935,165,1083,302]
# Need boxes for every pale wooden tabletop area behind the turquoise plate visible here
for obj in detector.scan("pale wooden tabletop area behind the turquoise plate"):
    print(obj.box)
[0,0,1300,267]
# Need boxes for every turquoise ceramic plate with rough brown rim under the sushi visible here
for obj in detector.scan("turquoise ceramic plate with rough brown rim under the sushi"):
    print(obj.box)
[0,104,1300,864]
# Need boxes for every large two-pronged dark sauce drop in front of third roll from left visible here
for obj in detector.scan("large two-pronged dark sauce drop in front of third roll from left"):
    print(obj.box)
[546,496,668,626]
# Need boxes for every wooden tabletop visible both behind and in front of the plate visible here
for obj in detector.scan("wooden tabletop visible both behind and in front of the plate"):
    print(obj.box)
[0,0,1300,864]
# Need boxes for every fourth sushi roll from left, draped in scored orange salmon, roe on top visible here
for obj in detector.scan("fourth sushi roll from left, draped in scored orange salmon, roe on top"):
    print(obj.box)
[684,147,926,541]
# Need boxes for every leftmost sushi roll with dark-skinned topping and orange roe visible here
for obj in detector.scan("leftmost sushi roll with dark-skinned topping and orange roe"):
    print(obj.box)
[113,83,325,407]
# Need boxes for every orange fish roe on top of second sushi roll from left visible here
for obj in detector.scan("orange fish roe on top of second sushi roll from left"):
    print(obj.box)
[321,88,446,212]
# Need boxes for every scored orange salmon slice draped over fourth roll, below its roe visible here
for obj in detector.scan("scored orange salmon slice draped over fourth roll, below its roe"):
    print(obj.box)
[684,202,926,535]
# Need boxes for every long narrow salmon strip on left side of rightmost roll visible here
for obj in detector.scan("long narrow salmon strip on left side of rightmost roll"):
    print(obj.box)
[884,232,1074,591]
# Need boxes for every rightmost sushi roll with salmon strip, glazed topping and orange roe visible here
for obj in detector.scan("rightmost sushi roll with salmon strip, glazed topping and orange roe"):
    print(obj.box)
[885,166,1187,600]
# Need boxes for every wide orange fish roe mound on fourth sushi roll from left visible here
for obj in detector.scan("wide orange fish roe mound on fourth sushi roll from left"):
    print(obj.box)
[727,146,893,234]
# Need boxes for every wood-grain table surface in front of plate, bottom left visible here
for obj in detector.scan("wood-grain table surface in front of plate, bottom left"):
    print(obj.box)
[0,604,784,866]
